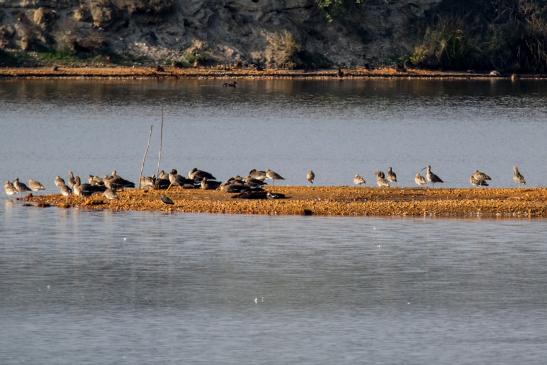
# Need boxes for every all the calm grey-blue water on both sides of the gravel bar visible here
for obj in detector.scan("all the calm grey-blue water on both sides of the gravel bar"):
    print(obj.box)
[0,80,547,365]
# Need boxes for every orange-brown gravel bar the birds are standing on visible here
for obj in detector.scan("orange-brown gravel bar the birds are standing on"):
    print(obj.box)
[25,186,547,218]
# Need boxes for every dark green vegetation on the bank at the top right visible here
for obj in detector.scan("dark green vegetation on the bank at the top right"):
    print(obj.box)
[409,0,547,73]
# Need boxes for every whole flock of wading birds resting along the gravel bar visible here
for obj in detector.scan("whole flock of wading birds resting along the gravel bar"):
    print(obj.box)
[4,165,526,204]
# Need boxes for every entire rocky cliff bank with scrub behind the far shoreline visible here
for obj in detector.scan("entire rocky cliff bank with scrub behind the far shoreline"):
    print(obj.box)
[0,0,547,72]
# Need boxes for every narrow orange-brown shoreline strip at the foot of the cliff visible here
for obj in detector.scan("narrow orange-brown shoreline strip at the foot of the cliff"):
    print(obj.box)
[0,66,547,81]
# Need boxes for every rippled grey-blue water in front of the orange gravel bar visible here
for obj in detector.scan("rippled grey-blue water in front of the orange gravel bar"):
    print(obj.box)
[0,203,547,364]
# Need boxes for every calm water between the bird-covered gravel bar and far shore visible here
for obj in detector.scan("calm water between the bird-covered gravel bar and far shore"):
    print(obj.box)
[0,80,547,186]
